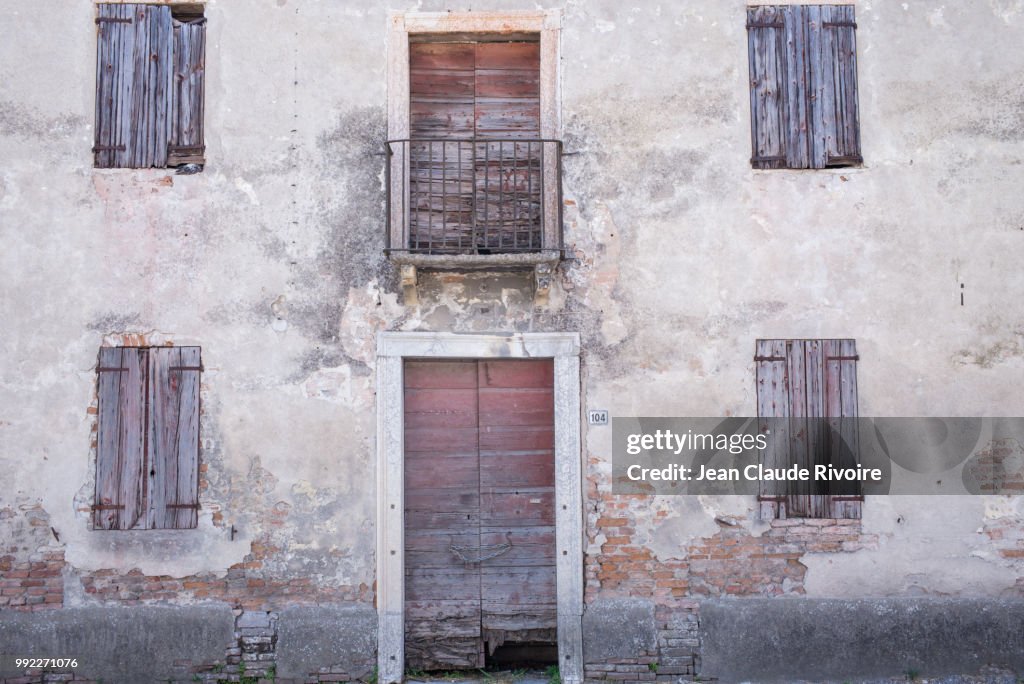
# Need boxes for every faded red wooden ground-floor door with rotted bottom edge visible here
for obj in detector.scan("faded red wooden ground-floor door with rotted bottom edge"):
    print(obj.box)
[404,359,556,670]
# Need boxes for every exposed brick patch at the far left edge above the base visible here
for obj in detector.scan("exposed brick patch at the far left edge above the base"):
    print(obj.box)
[0,503,65,610]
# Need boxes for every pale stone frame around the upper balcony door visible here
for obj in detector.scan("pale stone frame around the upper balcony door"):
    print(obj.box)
[387,9,562,253]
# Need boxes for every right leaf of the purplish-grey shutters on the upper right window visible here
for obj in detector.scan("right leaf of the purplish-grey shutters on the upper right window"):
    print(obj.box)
[807,5,863,168]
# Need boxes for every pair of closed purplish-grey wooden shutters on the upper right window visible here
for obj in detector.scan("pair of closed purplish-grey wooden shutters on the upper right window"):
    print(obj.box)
[746,5,863,169]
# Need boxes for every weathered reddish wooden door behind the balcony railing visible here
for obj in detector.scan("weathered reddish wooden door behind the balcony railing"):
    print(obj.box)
[408,34,551,254]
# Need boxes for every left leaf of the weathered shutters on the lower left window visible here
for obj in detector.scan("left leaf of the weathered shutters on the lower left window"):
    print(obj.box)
[92,347,146,529]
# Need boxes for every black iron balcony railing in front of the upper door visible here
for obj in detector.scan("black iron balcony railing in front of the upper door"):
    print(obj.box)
[385,138,562,255]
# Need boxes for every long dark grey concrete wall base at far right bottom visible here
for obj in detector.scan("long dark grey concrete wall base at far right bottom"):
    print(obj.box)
[699,599,1024,683]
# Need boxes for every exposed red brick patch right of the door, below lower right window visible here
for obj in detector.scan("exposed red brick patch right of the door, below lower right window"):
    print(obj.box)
[585,490,878,681]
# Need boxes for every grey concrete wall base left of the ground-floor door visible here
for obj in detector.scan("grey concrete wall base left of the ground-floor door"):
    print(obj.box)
[0,604,377,684]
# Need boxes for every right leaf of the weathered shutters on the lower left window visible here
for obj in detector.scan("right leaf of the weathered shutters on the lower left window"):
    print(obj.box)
[146,347,200,529]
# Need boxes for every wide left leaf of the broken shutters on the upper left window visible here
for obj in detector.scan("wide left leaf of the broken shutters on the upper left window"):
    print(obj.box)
[93,4,173,168]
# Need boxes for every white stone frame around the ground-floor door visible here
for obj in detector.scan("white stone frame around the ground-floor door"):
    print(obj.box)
[377,333,584,684]
